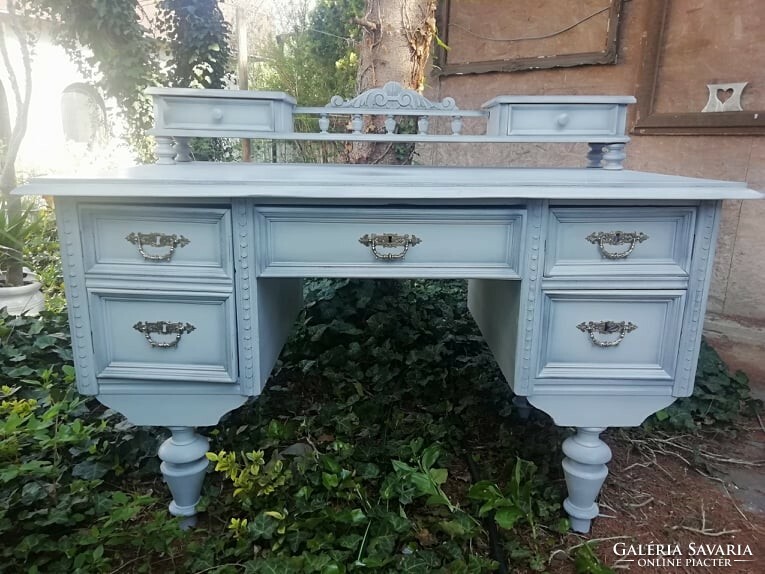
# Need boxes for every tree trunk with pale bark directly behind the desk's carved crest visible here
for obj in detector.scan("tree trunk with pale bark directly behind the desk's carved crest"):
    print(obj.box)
[350,0,438,163]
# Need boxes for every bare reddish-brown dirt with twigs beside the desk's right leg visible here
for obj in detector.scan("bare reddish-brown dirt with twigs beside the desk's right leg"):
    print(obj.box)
[551,419,765,574]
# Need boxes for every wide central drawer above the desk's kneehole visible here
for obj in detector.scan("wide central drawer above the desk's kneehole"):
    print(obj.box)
[256,207,525,278]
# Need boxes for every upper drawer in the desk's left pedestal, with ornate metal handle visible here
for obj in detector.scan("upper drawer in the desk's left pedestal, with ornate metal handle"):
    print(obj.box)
[81,206,233,278]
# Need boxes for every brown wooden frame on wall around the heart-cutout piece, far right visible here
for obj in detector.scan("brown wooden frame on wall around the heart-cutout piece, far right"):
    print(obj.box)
[632,0,765,135]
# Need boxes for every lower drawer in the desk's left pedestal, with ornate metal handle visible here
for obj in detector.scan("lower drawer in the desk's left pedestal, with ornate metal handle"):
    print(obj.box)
[90,291,237,383]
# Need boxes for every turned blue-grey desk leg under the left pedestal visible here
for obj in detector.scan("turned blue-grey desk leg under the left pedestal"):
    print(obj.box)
[159,427,209,529]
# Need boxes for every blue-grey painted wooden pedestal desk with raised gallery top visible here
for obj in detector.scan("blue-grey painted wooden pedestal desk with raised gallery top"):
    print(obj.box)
[16,86,760,532]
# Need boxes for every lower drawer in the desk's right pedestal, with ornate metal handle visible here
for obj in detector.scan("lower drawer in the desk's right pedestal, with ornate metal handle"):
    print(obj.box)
[537,290,685,381]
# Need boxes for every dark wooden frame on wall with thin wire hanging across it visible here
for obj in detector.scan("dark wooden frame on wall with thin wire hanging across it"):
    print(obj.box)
[434,0,623,76]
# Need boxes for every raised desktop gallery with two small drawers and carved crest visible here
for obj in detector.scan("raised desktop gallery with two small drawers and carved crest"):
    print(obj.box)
[147,82,635,169]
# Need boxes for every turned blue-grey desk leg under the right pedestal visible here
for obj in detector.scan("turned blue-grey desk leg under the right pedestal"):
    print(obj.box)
[563,427,611,532]
